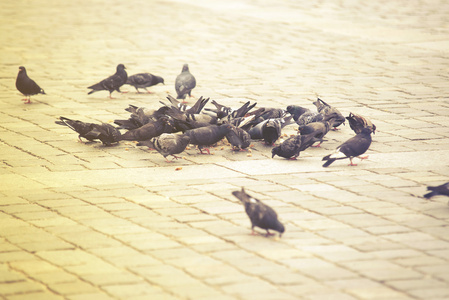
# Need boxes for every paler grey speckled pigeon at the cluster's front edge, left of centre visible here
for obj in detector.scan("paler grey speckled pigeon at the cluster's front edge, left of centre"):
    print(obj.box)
[151,133,190,162]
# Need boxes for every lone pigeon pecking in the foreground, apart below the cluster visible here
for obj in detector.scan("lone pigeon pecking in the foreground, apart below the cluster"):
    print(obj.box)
[232,187,285,237]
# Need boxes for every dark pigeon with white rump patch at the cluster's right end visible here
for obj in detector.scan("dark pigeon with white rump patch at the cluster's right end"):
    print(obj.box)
[323,128,371,167]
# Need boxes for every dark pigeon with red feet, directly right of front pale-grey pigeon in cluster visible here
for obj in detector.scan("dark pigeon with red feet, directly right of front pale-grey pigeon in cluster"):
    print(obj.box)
[184,124,232,154]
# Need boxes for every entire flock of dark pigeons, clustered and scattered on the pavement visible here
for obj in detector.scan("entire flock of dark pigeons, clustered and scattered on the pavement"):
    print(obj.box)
[16,64,449,235]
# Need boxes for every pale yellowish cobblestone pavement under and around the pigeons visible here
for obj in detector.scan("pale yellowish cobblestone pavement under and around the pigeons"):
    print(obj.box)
[0,0,449,300]
